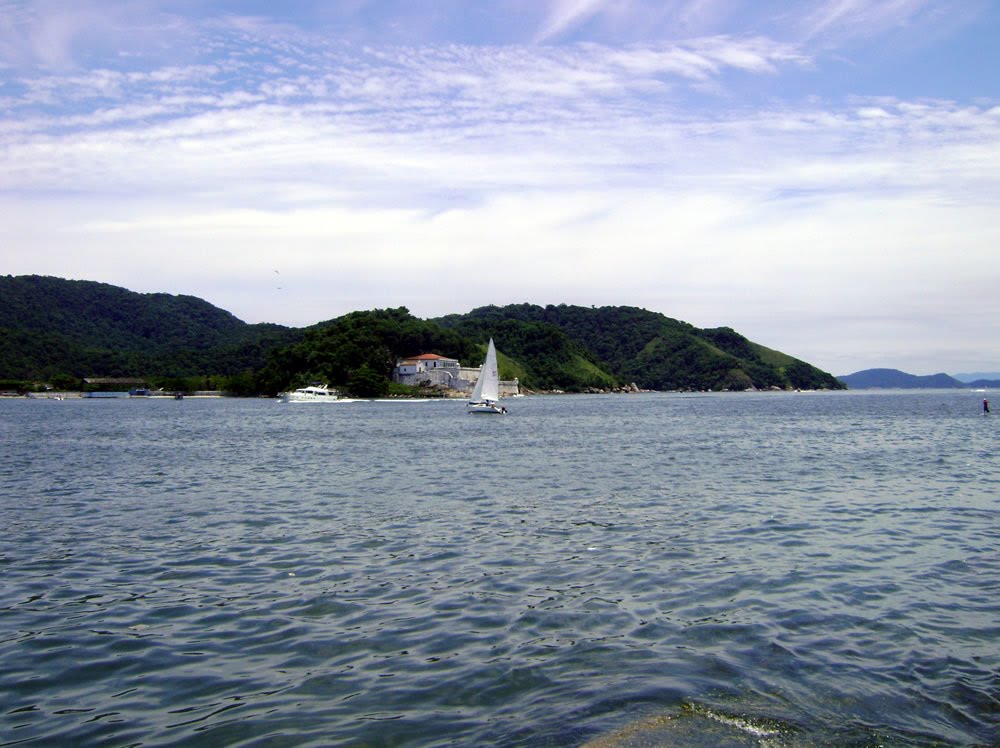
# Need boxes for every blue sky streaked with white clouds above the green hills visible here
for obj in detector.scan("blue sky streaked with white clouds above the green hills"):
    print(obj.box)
[0,0,1000,375]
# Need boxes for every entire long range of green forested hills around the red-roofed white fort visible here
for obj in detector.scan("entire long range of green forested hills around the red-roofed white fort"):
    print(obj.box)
[0,275,846,397]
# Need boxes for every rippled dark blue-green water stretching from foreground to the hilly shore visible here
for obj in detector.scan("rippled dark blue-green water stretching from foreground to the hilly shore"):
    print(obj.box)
[0,392,1000,746]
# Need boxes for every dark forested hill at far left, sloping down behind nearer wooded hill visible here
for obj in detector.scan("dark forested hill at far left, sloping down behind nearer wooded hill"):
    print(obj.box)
[0,275,301,379]
